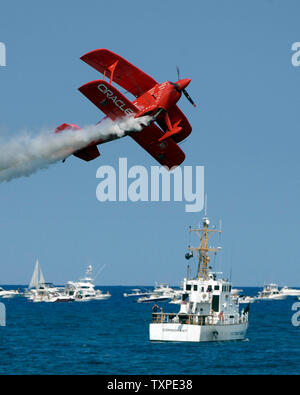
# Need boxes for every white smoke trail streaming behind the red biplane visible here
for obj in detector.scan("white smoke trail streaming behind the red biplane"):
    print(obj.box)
[0,116,151,182]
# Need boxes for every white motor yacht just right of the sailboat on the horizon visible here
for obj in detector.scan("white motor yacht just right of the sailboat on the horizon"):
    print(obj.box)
[65,265,111,302]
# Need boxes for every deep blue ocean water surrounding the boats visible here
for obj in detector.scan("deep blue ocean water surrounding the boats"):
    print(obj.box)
[0,286,300,375]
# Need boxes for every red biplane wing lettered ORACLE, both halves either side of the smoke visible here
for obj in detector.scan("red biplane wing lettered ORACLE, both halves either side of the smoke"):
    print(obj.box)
[79,80,185,168]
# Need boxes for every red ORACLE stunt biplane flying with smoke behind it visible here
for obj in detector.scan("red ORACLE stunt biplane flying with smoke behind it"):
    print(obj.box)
[56,49,196,168]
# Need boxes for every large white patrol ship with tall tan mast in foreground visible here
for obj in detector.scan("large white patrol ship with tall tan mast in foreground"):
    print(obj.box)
[149,215,249,342]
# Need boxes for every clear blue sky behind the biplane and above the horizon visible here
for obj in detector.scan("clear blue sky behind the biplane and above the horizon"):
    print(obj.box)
[0,0,300,286]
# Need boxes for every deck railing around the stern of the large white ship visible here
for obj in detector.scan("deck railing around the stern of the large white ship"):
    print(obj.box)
[152,312,248,326]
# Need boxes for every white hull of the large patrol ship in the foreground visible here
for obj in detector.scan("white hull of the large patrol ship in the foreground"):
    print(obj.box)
[149,322,248,342]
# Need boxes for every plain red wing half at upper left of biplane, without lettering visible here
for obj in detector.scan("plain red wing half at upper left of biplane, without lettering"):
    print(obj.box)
[80,49,157,97]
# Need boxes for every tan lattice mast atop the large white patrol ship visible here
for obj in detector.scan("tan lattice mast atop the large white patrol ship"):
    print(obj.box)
[188,217,222,280]
